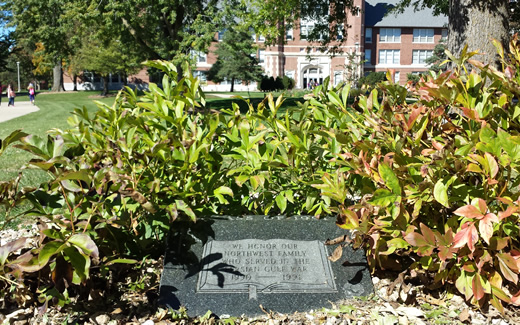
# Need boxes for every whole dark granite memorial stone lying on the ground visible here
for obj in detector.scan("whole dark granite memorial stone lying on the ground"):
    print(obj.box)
[160,216,373,316]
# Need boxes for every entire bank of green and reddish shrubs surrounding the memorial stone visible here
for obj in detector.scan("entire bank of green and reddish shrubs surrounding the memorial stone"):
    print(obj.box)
[0,39,520,310]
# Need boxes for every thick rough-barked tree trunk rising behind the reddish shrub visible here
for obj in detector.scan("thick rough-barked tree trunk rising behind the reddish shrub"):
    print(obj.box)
[448,0,510,67]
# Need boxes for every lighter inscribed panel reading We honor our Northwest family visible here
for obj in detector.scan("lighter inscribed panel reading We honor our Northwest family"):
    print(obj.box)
[197,239,337,299]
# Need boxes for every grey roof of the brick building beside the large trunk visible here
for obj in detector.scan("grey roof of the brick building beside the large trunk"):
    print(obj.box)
[365,0,448,27]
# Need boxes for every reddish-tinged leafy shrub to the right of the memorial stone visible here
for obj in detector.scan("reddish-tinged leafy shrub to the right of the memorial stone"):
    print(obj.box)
[314,39,520,312]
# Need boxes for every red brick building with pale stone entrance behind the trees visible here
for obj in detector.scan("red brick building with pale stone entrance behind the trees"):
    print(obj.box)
[65,0,448,91]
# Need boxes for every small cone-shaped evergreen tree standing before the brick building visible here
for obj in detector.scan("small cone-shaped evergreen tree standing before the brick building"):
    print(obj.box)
[208,28,262,92]
